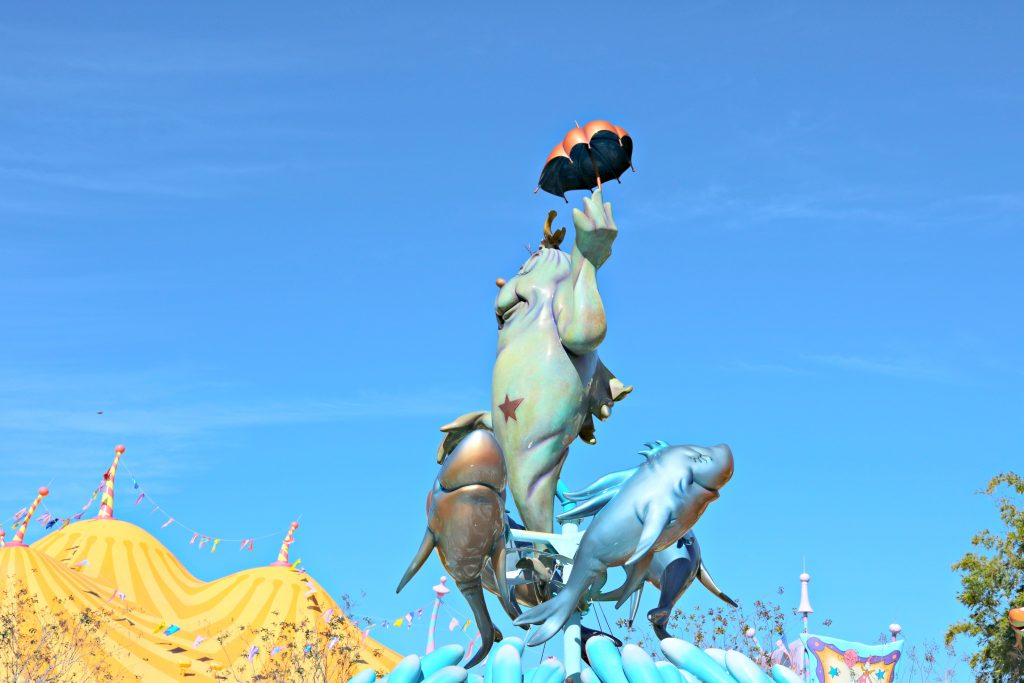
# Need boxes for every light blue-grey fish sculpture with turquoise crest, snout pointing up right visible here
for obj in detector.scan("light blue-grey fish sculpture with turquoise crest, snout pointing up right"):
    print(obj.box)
[516,442,733,645]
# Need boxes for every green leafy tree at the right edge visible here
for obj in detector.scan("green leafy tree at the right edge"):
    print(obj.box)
[946,472,1024,682]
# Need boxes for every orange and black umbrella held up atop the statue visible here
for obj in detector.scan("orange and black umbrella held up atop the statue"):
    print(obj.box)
[535,121,633,202]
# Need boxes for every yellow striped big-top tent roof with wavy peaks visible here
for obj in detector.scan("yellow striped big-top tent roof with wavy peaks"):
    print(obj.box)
[0,519,400,683]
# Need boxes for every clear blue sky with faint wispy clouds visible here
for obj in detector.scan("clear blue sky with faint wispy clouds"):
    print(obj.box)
[0,2,1024,667]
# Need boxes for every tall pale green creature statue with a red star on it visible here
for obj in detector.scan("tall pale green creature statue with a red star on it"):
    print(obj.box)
[437,189,632,531]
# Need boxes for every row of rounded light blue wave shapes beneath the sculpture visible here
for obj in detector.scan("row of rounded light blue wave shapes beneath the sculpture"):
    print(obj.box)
[356,636,803,683]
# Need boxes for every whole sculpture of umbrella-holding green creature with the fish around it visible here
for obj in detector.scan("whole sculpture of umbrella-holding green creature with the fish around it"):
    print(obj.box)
[392,121,734,681]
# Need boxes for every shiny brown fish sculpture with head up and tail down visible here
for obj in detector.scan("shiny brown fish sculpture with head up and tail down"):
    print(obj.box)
[395,430,519,669]
